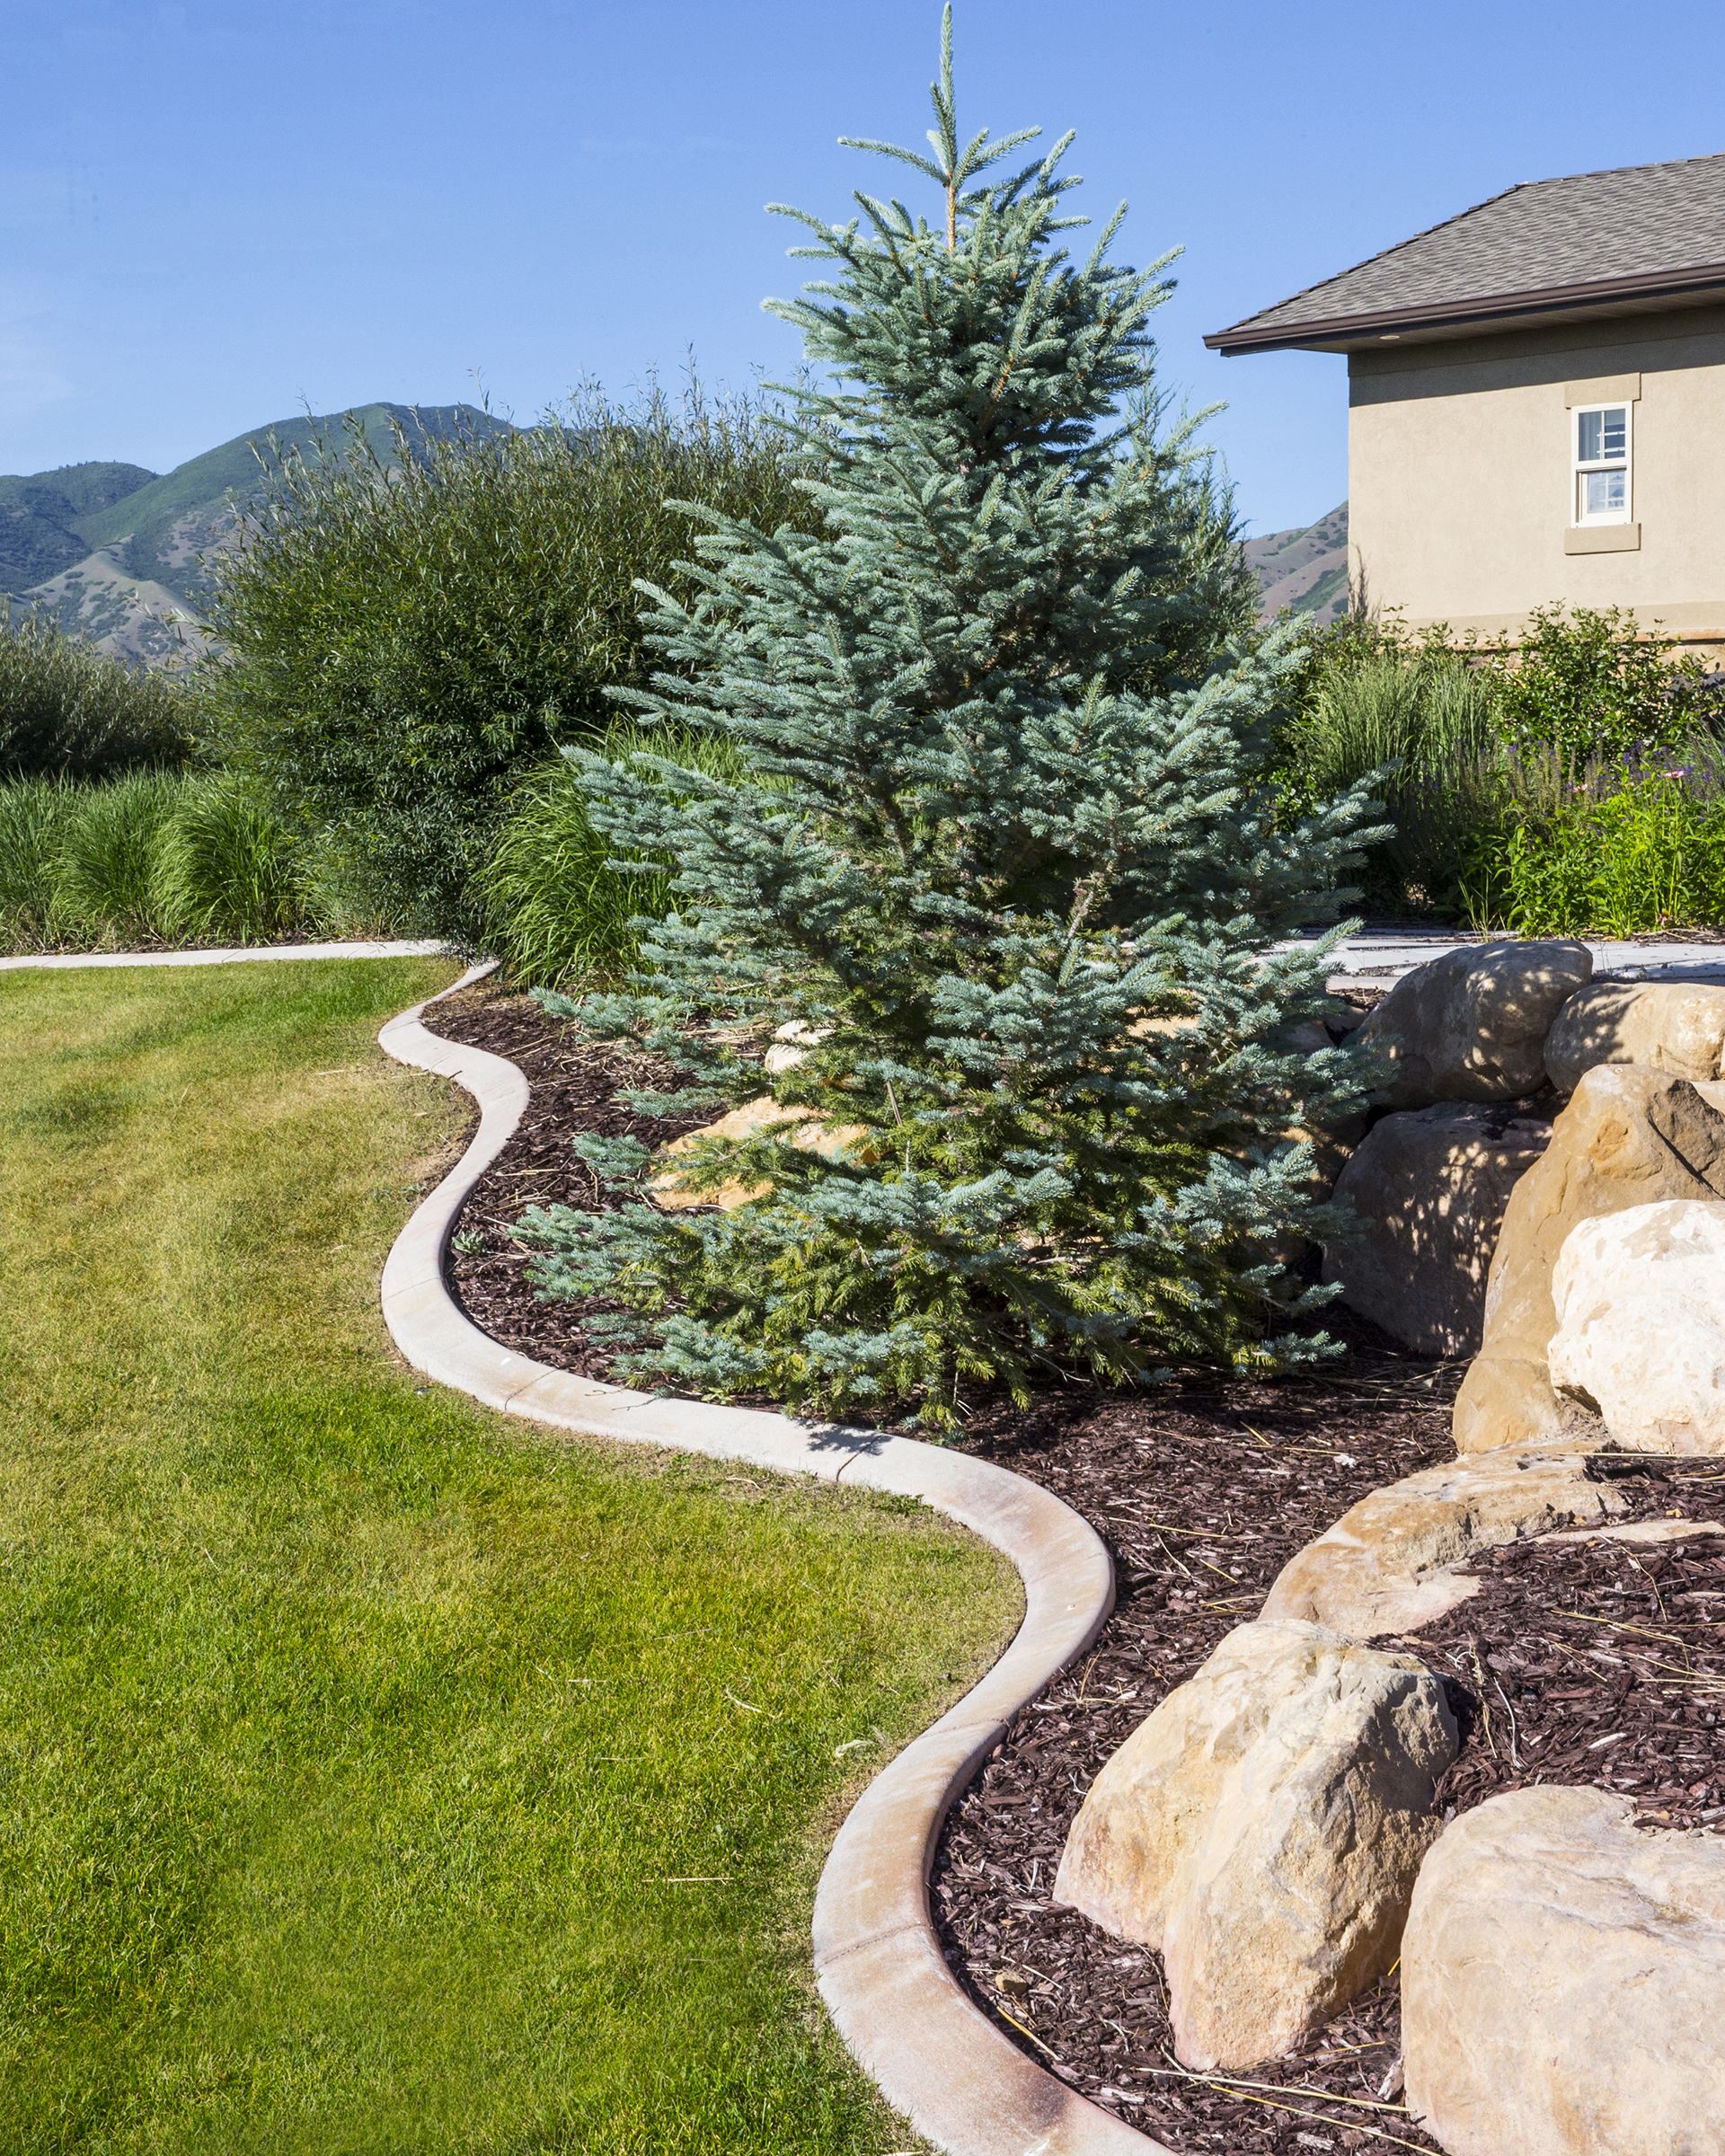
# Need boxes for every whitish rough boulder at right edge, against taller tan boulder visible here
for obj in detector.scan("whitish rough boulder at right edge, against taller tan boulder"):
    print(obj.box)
[1546,1198,1725,1454]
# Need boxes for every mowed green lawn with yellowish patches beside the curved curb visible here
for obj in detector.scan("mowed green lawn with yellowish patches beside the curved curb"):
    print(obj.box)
[0,961,1018,2156]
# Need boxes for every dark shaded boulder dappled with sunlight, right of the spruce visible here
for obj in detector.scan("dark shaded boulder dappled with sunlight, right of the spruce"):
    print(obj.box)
[1324,1101,1551,1356]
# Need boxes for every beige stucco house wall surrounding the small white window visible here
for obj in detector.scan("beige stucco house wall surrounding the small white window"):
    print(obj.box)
[1348,308,1725,642]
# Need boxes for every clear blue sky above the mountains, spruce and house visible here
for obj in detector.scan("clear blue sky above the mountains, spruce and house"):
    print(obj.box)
[0,0,1725,530]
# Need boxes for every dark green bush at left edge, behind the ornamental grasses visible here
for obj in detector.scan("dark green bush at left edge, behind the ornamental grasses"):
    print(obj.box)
[0,599,190,781]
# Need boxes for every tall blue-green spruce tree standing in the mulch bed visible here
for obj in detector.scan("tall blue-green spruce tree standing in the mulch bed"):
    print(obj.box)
[519,11,1376,1427]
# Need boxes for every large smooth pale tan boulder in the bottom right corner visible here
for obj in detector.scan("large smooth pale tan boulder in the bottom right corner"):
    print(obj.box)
[1402,1789,1725,2156]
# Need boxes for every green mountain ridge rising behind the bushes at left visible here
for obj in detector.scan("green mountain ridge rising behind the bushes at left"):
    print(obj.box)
[0,403,509,664]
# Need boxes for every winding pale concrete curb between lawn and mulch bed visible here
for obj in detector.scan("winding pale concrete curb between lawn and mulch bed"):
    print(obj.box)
[377,966,1166,2156]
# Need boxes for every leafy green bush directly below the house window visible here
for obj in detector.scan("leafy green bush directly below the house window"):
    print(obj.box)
[1488,605,1702,764]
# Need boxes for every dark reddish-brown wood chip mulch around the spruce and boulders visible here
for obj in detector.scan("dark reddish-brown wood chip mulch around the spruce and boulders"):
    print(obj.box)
[418,987,1725,2156]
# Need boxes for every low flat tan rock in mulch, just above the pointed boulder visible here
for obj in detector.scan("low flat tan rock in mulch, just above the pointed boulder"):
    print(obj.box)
[1260,1446,1628,1639]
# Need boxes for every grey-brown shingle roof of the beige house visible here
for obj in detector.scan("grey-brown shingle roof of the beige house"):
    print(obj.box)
[1206,155,1725,347]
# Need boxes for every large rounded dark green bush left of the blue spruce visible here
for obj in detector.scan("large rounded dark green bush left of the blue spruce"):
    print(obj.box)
[205,390,818,942]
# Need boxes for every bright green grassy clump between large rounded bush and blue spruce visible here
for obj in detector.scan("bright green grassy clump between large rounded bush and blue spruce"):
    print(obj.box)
[479,720,742,987]
